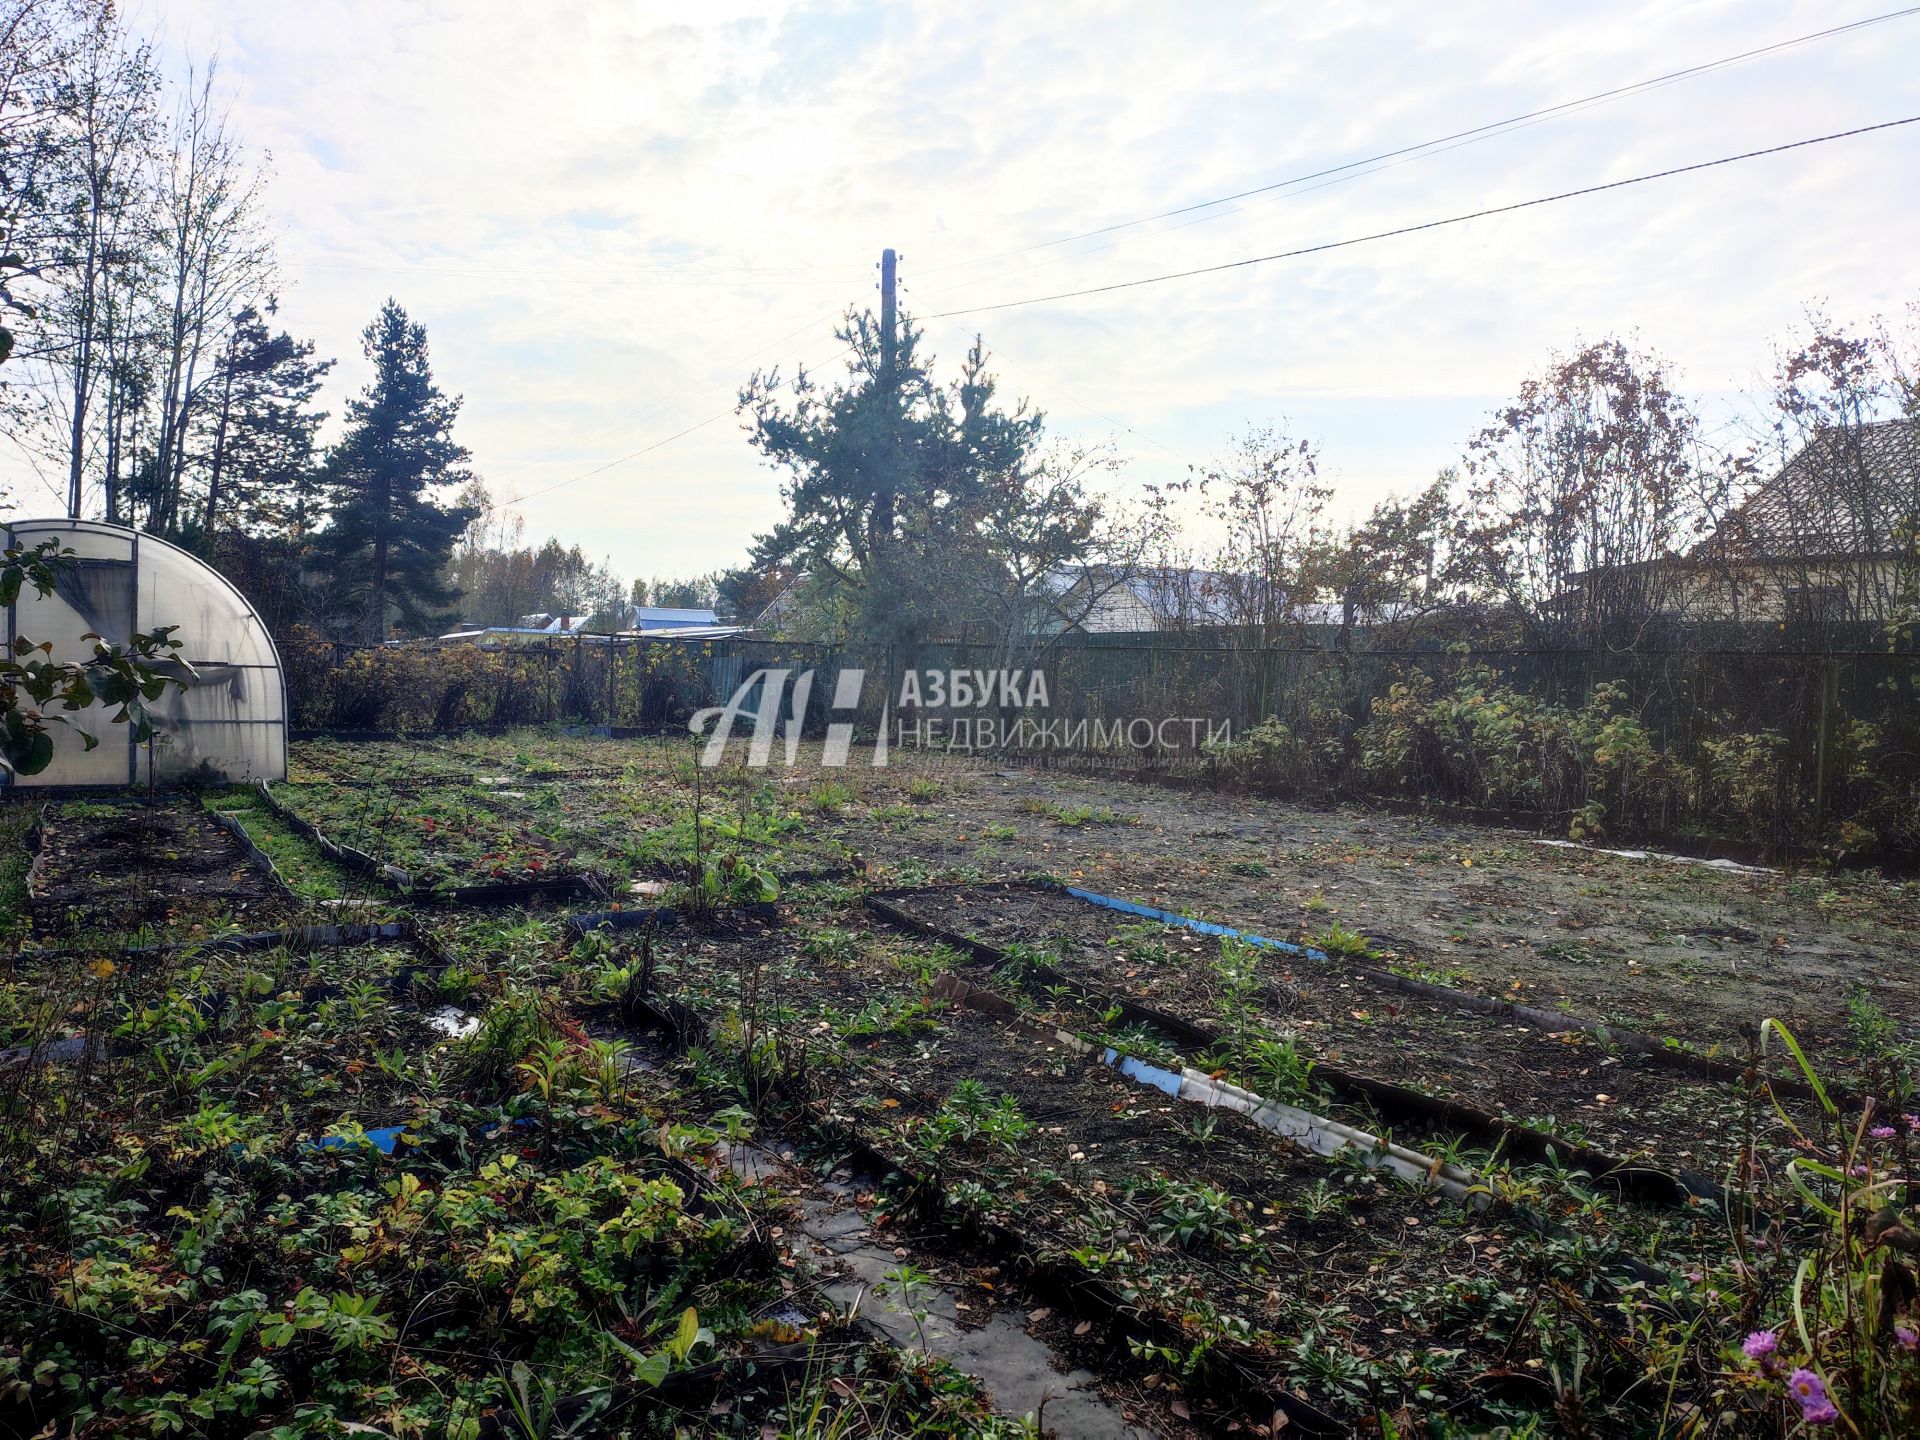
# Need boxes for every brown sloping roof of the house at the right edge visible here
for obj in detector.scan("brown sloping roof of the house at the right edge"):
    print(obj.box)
[1692,420,1920,561]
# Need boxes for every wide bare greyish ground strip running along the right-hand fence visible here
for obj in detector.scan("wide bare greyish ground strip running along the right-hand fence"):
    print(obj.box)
[783,751,1920,1056]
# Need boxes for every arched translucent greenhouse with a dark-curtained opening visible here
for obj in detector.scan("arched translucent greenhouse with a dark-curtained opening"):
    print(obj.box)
[0,520,286,787]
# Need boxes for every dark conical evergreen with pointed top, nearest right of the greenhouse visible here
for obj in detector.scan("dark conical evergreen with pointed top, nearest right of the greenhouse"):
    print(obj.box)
[315,300,474,643]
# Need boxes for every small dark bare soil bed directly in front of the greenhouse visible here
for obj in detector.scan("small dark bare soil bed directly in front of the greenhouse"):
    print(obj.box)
[33,795,292,941]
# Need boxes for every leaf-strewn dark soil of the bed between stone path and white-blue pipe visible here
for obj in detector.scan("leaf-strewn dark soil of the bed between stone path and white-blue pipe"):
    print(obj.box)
[614,914,1681,1421]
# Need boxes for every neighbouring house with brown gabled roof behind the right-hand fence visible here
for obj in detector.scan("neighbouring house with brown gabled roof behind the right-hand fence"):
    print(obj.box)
[1668,420,1920,624]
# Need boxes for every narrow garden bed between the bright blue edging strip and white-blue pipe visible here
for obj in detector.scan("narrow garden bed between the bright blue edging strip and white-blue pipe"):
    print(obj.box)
[887,885,1820,1179]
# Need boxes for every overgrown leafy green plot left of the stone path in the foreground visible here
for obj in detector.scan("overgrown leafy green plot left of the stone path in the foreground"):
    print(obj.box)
[0,917,1012,1436]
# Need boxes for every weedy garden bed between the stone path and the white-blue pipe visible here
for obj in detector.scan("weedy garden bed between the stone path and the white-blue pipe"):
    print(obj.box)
[599,924,1712,1423]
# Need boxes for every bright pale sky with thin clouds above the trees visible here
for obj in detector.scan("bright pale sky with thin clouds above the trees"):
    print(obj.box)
[116,0,1920,576]
